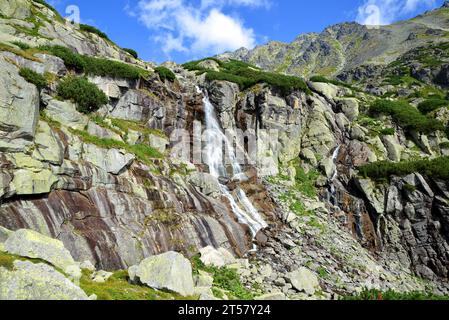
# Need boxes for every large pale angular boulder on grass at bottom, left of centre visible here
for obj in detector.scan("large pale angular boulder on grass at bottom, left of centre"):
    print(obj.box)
[130,251,194,296]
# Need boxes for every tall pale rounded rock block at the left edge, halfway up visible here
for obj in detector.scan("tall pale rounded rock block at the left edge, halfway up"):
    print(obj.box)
[0,58,39,152]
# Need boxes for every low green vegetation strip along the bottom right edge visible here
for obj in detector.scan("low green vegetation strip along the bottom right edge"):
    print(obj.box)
[342,289,449,301]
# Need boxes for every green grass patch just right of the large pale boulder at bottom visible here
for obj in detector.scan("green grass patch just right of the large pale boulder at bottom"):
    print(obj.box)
[192,256,255,300]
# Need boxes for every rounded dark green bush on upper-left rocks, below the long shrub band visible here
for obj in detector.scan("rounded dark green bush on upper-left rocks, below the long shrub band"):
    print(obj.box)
[57,77,108,113]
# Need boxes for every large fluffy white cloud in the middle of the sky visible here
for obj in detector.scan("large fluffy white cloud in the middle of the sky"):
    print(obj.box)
[127,0,270,55]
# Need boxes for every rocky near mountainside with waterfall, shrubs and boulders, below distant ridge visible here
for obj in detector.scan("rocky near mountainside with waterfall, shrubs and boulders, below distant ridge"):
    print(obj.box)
[0,0,449,299]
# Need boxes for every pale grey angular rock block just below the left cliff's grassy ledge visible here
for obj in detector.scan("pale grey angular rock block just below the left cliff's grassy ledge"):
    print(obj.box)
[83,144,135,174]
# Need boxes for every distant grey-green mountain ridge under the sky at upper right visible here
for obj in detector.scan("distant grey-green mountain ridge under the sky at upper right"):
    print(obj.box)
[219,4,449,77]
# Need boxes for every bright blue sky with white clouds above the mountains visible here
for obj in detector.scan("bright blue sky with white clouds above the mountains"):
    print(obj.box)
[48,0,444,62]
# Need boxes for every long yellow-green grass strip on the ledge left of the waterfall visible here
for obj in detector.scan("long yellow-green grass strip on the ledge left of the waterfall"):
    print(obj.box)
[70,129,163,164]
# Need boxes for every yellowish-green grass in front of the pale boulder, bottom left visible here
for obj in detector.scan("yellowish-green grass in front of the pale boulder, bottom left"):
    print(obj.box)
[80,271,198,300]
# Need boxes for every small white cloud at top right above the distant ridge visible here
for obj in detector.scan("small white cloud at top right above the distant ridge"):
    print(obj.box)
[357,0,435,25]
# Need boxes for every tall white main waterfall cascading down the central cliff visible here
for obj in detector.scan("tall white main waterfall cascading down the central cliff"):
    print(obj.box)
[198,89,268,237]
